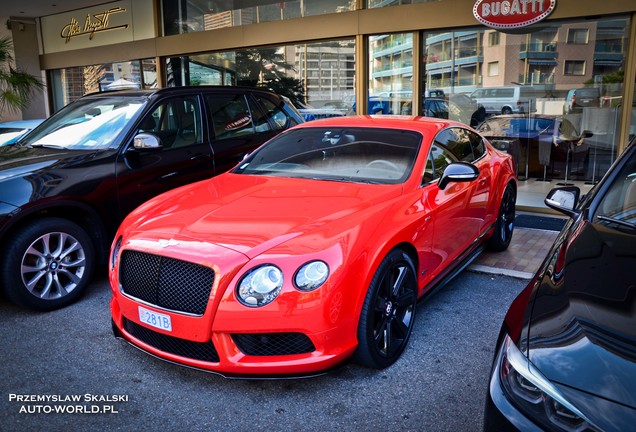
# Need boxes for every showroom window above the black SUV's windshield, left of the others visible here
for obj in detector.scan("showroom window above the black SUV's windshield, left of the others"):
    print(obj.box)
[50,59,157,110]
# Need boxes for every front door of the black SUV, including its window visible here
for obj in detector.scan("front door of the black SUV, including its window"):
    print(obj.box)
[117,93,215,217]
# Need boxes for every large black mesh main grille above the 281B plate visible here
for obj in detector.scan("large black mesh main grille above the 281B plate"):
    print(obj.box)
[119,250,214,315]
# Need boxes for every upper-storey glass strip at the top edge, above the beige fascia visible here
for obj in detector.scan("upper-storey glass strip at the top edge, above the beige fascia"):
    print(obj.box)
[162,0,355,36]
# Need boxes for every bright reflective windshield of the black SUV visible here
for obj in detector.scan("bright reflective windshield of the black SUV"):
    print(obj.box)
[20,96,146,150]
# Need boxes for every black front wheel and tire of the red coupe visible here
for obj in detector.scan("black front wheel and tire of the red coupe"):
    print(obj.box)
[354,249,417,369]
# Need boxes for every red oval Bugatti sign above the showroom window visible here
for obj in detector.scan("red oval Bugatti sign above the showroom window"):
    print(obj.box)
[473,0,556,30]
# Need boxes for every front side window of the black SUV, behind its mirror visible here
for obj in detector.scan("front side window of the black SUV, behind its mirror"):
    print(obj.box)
[139,96,203,149]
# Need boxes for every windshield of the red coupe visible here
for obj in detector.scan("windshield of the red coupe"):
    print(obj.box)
[234,127,422,184]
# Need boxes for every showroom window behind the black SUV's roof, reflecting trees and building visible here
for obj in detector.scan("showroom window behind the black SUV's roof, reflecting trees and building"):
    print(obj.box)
[166,40,355,120]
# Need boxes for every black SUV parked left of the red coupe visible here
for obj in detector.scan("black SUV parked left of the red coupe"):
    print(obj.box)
[0,87,303,310]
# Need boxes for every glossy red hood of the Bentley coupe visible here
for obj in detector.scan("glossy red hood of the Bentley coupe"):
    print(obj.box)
[124,173,402,258]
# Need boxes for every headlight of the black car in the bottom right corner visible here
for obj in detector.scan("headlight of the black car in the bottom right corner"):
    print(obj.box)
[497,335,598,432]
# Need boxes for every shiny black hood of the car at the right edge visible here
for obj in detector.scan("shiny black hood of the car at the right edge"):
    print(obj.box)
[528,220,636,410]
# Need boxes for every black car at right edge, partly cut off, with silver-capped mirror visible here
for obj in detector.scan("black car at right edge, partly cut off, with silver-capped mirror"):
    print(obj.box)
[484,141,636,431]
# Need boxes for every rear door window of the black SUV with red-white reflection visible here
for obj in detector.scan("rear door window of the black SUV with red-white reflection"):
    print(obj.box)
[205,93,256,139]
